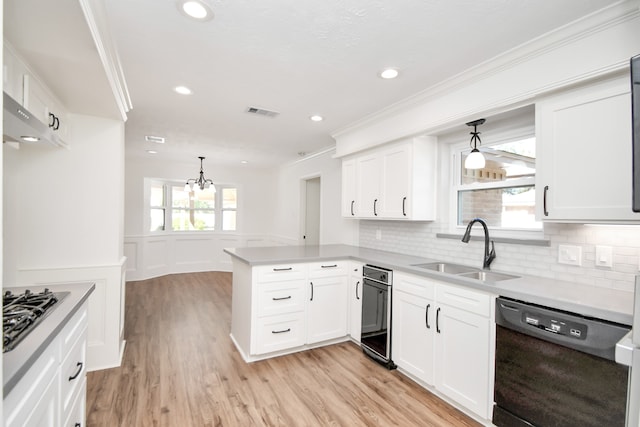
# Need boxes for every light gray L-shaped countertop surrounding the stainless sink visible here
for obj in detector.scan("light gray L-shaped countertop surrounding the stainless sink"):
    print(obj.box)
[224,245,633,325]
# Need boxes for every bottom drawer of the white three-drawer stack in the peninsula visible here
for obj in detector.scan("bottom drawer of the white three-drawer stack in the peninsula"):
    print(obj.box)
[253,313,305,354]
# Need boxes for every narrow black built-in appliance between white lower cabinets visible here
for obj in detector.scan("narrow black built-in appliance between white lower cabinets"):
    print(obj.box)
[360,265,395,369]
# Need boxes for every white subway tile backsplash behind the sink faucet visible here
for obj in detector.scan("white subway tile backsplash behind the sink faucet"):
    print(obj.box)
[360,220,640,292]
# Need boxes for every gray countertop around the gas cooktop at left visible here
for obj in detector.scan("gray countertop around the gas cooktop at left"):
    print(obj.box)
[2,283,95,396]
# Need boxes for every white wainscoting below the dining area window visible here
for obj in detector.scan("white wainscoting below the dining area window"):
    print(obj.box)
[124,233,298,281]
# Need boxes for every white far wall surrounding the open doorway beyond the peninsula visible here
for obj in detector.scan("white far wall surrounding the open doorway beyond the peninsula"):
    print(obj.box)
[273,151,358,245]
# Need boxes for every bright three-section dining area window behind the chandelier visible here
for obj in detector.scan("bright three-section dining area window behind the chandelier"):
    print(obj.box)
[149,181,238,232]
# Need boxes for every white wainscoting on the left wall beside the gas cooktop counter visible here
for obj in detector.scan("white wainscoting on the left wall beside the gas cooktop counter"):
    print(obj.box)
[16,257,127,371]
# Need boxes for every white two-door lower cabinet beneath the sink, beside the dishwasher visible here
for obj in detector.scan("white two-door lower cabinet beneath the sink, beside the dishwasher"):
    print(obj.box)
[392,272,495,419]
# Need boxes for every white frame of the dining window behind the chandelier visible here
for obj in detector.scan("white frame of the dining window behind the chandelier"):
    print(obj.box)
[144,178,241,235]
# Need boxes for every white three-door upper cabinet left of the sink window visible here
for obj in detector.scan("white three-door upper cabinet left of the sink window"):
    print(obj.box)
[342,136,437,221]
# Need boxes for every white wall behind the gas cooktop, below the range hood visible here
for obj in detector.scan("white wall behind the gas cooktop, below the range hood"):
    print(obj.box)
[3,114,124,370]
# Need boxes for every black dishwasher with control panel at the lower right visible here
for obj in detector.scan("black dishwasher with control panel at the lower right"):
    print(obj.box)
[493,297,629,427]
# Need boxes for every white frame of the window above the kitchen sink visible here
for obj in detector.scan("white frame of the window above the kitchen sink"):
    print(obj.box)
[449,126,544,240]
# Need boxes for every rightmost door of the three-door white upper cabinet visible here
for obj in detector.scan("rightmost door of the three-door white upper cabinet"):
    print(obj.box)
[380,144,411,219]
